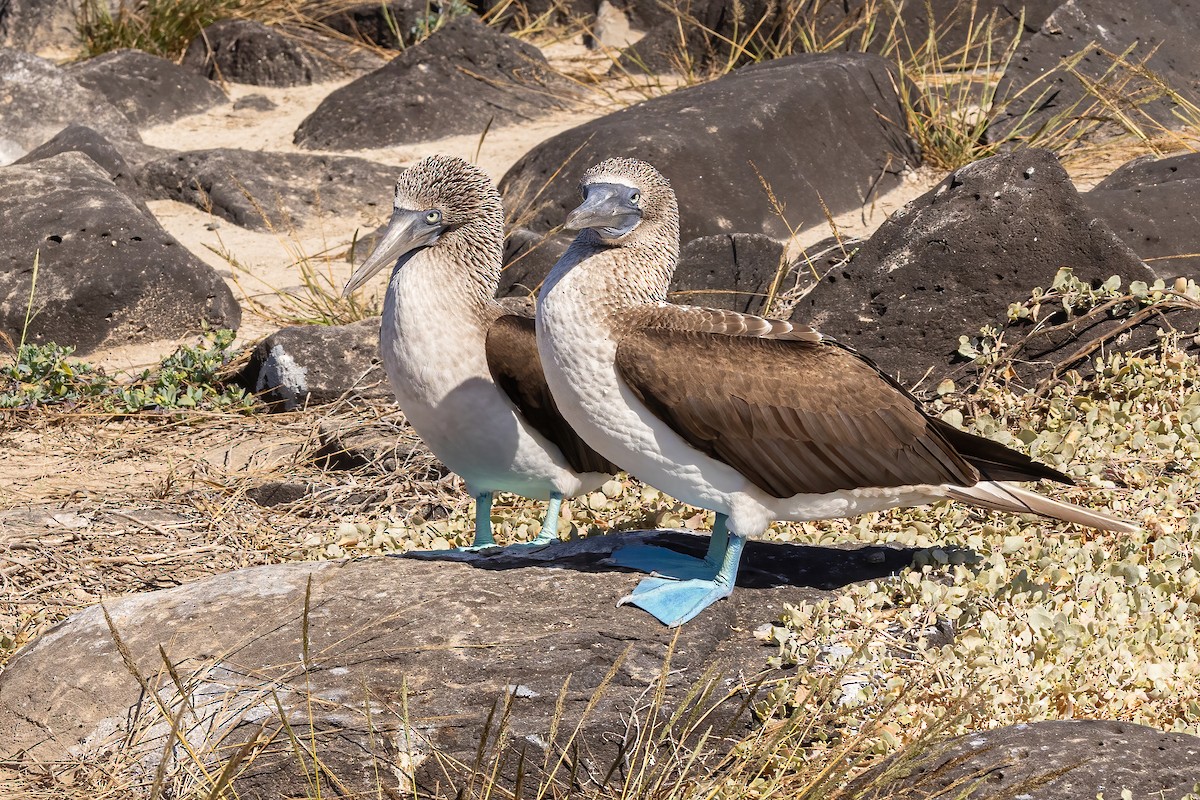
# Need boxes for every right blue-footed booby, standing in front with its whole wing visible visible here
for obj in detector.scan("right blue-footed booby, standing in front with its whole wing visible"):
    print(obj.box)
[536,158,1136,625]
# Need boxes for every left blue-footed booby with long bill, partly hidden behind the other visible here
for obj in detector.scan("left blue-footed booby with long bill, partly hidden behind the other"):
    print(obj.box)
[344,156,617,548]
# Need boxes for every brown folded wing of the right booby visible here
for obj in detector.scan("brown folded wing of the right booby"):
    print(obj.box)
[617,311,979,498]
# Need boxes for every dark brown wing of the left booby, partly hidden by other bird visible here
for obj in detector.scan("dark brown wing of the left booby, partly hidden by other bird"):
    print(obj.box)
[485,314,619,473]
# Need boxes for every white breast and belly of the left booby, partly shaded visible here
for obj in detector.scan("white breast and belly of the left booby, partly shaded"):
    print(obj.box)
[379,251,604,499]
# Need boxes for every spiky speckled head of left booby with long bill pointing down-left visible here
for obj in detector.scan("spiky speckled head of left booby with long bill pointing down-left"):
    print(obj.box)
[342,156,504,296]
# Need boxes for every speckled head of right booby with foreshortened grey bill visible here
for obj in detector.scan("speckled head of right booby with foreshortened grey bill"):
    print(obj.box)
[563,158,679,246]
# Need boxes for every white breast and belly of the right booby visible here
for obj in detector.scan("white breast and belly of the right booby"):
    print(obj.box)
[538,267,940,536]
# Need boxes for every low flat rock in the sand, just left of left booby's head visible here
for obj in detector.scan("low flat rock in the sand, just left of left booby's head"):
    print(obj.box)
[138,149,396,230]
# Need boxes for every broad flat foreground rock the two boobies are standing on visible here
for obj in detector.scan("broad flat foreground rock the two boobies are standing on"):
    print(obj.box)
[0,531,912,800]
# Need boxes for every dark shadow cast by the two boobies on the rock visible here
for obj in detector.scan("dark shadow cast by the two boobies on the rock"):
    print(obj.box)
[398,530,919,590]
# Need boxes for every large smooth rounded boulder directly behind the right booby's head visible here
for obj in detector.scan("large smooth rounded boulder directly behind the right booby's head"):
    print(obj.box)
[500,54,919,287]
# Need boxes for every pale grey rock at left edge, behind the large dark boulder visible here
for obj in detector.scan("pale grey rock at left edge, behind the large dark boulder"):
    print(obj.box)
[0,48,144,157]
